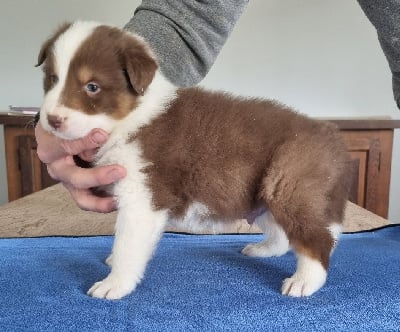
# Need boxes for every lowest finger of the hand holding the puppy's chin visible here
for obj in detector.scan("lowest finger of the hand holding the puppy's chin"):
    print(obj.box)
[66,186,117,213]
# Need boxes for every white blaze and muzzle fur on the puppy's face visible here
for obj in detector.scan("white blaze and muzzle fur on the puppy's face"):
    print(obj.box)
[40,22,119,139]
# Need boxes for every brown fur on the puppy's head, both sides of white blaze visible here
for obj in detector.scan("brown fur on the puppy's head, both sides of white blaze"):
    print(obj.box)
[38,24,158,119]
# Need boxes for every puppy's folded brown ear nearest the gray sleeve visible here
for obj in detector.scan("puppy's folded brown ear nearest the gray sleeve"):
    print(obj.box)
[123,36,158,96]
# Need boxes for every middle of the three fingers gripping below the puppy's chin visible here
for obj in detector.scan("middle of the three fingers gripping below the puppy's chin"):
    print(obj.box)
[47,156,126,189]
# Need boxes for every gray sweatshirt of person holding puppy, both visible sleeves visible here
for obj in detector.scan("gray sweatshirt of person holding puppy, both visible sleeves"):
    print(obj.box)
[125,0,400,108]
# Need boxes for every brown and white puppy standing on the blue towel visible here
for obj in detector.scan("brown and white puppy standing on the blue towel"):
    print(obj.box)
[38,22,349,299]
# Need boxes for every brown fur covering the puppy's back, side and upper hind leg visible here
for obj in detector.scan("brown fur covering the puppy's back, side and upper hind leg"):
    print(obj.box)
[135,88,349,268]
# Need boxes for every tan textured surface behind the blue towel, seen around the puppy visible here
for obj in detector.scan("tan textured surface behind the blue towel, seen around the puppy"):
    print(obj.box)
[0,184,389,237]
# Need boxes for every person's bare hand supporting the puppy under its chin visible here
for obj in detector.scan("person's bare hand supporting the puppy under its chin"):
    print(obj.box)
[35,123,126,213]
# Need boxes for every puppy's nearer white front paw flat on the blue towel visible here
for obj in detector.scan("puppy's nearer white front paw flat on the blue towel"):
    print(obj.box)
[87,275,136,300]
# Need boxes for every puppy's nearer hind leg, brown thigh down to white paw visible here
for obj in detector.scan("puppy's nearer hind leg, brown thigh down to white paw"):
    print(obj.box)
[261,140,346,297]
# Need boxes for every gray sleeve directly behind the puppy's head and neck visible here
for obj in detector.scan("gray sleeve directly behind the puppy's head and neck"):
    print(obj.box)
[125,0,248,87]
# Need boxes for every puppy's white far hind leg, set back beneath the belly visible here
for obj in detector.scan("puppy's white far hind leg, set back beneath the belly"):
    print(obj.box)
[242,211,290,257]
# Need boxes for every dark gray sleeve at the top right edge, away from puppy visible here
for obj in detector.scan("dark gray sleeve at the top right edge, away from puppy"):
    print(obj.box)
[358,0,400,108]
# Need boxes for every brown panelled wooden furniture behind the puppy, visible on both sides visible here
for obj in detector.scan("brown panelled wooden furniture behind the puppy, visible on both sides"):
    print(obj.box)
[0,114,400,218]
